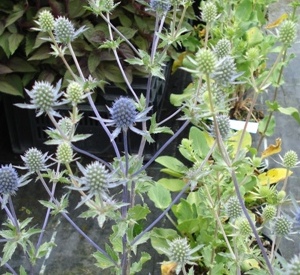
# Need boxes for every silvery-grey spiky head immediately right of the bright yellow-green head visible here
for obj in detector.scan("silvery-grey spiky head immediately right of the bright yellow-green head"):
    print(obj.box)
[213,56,237,86]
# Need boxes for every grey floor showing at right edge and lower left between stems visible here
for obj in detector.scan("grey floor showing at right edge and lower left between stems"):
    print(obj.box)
[0,0,300,275]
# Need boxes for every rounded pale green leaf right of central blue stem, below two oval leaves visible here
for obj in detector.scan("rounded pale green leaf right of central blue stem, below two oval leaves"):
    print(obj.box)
[148,183,172,210]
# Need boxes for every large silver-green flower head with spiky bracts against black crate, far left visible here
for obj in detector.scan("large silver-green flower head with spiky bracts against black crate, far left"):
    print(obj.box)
[16,80,64,116]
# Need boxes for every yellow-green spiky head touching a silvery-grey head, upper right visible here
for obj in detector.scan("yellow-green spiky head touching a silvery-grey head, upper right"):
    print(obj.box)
[196,49,217,74]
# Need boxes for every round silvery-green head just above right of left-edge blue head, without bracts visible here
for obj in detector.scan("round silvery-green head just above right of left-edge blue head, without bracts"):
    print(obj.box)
[21,148,48,172]
